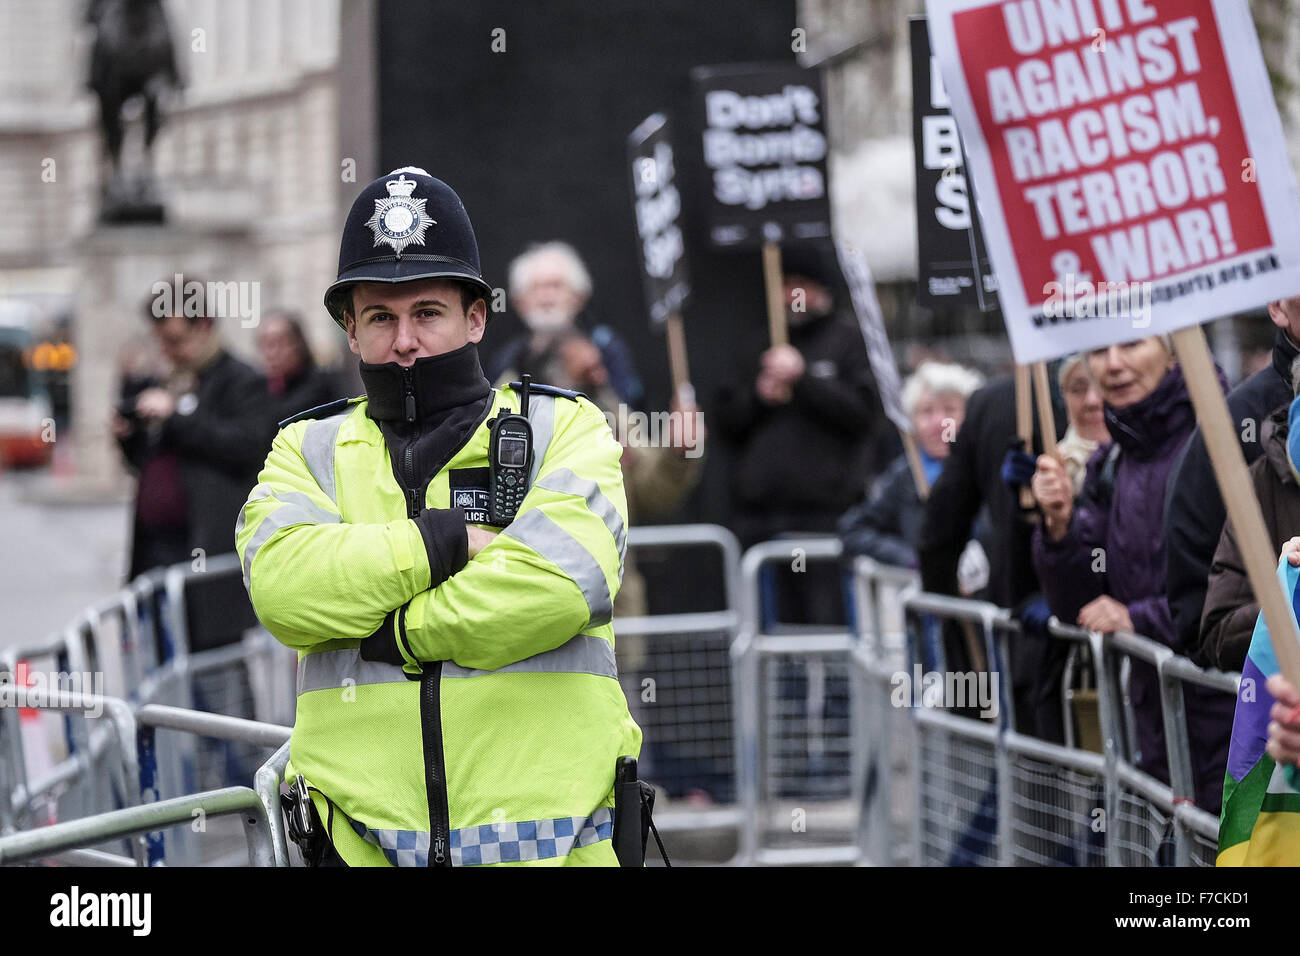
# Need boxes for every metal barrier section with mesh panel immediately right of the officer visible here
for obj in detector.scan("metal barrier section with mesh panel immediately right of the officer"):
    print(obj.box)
[614,524,741,849]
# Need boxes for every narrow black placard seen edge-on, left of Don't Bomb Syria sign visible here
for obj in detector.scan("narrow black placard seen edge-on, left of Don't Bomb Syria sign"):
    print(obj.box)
[628,113,690,328]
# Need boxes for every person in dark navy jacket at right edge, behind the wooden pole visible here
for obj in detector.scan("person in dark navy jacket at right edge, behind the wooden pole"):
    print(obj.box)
[1165,297,1300,663]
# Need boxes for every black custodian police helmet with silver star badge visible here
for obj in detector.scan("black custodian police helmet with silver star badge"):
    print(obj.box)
[325,166,491,335]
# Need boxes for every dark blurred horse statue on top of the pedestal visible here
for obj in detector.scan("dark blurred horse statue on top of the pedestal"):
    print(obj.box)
[86,0,185,222]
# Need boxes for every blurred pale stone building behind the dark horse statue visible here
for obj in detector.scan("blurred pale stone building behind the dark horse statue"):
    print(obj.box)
[0,0,373,489]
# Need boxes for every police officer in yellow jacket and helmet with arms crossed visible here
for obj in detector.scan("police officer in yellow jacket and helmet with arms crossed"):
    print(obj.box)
[235,166,641,866]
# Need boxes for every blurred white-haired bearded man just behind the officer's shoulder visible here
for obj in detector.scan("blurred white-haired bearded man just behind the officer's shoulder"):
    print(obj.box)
[486,241,644,408]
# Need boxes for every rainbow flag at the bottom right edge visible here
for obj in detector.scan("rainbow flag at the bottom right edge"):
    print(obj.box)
[1217,559,1300,866]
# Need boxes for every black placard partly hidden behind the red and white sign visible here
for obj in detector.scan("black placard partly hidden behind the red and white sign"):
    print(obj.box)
[910,17,997,312]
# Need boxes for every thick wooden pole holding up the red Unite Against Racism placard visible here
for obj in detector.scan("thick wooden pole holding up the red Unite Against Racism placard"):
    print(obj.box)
[1174,325,1300,687]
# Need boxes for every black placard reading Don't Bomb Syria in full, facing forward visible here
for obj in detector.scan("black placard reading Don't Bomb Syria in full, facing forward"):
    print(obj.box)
[690,64,831,247]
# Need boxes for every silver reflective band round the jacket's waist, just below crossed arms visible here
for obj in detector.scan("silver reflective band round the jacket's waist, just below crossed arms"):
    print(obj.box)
[298,633,619,695]
